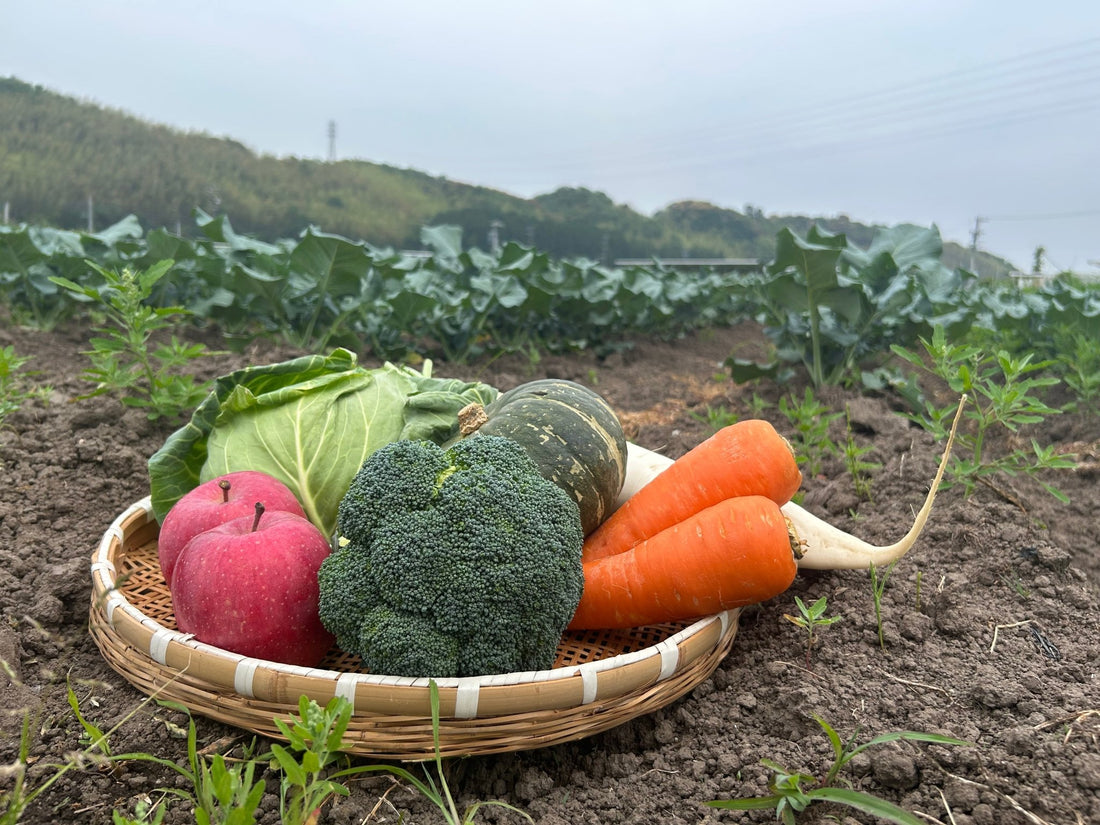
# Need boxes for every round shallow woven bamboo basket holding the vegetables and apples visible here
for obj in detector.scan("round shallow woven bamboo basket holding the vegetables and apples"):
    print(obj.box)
[89,498,739,760]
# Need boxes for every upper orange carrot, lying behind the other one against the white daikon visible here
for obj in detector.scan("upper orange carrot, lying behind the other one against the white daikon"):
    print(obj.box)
[584,419,802,561]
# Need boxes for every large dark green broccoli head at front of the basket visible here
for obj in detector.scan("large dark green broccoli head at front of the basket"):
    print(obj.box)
[318,436,584,678]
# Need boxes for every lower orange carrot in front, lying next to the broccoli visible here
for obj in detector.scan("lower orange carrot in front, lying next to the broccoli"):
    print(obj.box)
[569,495,798,629]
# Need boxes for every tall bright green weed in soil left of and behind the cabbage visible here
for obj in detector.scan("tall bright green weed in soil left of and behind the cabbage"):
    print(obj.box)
[51,260,216,419]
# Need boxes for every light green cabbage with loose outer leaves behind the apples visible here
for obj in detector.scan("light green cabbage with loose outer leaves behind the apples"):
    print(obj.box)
[149,349,497,536]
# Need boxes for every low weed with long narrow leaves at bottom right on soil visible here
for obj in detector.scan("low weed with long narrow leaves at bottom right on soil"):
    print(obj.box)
[706,715,971,825]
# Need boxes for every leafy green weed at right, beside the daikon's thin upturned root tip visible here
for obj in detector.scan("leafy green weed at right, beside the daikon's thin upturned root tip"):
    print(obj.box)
[893,326,1075,502]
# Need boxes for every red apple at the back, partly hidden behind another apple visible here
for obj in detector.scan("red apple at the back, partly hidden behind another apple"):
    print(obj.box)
[156,470,306,587]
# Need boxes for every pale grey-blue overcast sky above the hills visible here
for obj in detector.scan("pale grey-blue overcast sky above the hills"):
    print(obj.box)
[0,0,1100,272]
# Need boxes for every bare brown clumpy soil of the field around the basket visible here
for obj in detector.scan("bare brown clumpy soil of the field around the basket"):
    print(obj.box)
[0,322,1100,825]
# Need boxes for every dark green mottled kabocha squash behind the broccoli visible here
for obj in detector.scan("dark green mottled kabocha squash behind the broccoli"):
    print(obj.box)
[459,378,627,535]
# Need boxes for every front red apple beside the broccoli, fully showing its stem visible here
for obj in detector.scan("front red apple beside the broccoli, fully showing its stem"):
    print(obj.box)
[172,505,333,667]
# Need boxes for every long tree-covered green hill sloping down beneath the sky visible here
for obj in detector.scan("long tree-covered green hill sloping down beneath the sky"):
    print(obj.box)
[0,78,1004,274]
